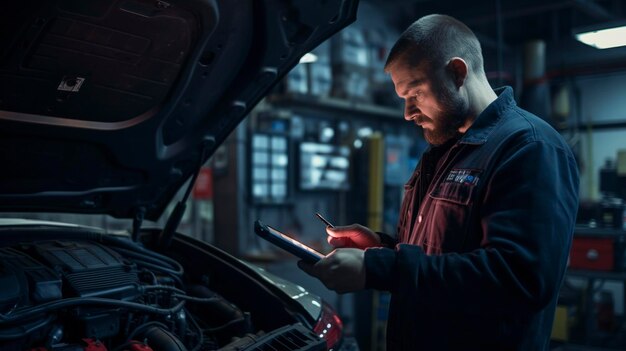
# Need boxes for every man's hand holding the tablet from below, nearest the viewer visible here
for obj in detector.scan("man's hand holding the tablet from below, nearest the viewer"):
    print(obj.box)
[298,249,365,294]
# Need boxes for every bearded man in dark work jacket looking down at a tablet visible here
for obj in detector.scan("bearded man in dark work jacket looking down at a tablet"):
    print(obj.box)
[299,15,579,350]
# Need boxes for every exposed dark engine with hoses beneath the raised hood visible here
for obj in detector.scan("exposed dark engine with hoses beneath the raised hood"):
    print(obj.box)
[0,240,280,351]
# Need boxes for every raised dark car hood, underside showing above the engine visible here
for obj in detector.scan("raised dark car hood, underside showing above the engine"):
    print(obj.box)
[0,0,357,220]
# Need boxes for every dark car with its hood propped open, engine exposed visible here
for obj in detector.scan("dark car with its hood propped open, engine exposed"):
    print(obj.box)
[0,0,357,351]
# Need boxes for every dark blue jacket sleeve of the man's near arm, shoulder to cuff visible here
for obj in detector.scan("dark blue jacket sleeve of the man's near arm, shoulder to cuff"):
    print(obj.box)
[365,141,579,313]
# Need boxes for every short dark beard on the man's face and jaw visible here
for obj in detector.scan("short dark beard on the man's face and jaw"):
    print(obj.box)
[418,86,469,145]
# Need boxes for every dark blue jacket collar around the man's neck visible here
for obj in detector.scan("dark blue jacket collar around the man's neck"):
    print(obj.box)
[459,86,516,145]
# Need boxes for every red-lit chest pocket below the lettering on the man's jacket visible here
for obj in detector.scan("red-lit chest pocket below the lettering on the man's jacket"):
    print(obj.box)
[424,175,476,253]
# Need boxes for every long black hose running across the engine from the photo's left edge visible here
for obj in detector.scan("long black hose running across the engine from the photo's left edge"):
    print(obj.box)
[0,297,185,324]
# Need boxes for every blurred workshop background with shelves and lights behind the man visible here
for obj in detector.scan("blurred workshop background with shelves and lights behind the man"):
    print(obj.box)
[2,0,626,351]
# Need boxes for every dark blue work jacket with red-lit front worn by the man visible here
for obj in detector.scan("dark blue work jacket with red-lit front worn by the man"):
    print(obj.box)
[365,87,579,351]
